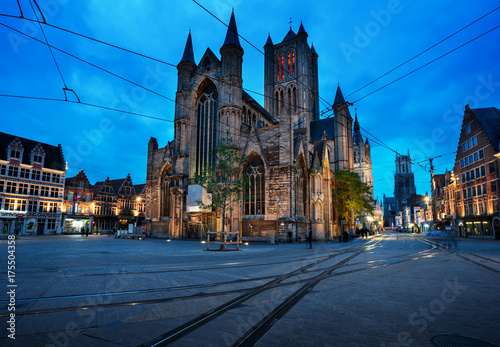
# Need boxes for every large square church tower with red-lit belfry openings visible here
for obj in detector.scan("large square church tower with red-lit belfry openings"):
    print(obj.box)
[264,23,319,136]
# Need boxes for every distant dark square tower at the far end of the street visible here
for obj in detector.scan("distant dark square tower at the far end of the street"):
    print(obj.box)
[394,150,417,214]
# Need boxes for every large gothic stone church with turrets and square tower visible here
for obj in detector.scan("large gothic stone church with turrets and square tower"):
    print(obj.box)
[146,12,364,242]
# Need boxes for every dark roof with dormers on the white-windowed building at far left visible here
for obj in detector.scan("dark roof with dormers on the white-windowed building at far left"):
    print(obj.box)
[0,132,66,171]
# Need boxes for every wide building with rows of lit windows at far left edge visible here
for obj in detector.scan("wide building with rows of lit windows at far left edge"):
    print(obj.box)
[0,133,66,235]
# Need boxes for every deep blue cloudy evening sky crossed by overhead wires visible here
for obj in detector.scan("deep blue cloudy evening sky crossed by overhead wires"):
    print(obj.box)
[0,0,500,198]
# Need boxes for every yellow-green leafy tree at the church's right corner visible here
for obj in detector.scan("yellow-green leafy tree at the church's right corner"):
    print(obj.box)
[332,169,373,230]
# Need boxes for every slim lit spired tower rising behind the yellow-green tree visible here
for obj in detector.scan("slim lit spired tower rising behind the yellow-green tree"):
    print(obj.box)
[353,109,373,198]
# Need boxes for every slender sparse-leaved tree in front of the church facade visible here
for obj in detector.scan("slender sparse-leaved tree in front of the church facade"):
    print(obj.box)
[194,139,246,248]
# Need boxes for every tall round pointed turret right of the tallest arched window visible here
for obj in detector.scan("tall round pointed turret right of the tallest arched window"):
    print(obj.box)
[219,11,244,145]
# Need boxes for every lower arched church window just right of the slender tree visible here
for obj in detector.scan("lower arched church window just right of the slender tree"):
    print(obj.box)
[243,154,266,215]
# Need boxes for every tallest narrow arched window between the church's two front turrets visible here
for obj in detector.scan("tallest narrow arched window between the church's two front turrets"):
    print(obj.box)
[196,81,219,173]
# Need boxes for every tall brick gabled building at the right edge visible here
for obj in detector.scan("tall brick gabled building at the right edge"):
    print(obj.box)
[453,105,500,238]
